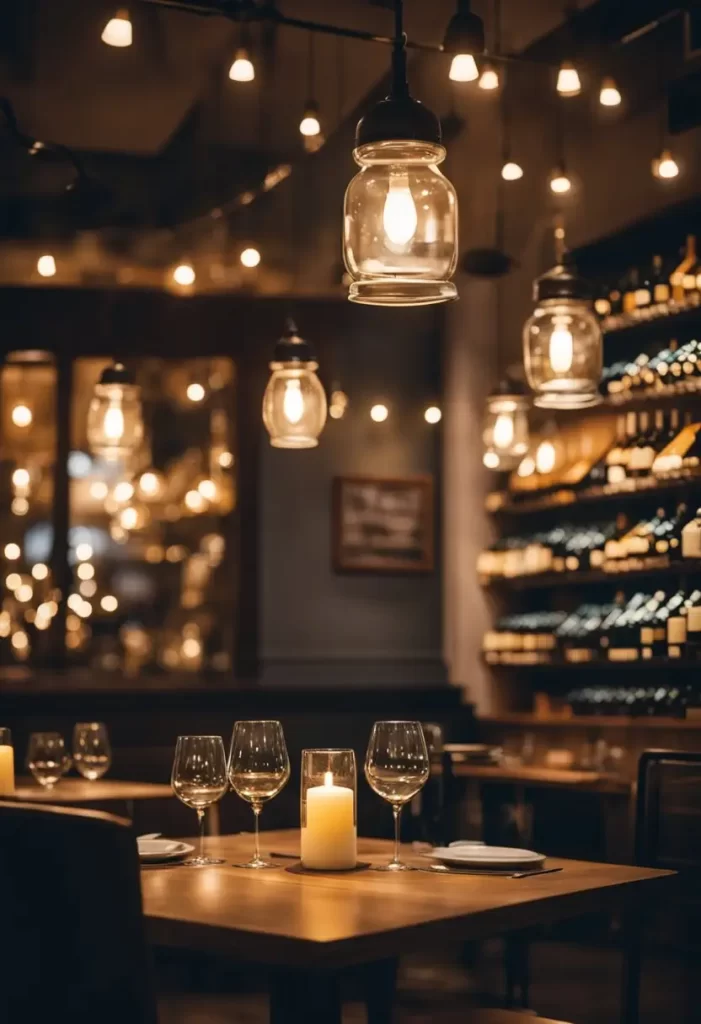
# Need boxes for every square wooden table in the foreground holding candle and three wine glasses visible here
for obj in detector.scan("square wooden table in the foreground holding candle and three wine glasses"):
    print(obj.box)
[141,830,671,1024]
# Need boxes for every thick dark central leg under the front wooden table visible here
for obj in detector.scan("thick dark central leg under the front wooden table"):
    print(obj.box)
[270,970,342,1024]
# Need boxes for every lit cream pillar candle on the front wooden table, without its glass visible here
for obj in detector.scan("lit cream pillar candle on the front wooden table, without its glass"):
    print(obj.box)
[302,771,357,871]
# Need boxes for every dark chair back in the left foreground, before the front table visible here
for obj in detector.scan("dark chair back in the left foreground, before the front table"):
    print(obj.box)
[0,802,157,1024]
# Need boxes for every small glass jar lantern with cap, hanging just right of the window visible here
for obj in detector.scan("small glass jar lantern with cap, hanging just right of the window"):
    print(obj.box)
[263,321,326,449]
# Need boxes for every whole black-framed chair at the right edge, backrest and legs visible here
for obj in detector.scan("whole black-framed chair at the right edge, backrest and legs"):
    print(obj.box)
[627,750,701,1024]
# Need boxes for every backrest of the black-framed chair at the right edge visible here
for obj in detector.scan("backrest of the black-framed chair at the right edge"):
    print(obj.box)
[636,751,701,871]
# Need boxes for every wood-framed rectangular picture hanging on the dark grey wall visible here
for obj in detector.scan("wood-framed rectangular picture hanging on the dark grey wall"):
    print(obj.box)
[332,476,434,572]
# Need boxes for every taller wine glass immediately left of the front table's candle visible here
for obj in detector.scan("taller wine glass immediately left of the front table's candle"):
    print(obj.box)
[228,722,290,868]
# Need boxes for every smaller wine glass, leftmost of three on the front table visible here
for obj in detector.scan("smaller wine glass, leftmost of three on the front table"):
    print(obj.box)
[171,736,226,867]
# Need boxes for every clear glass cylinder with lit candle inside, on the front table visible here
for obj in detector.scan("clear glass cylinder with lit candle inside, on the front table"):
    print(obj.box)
[301,750,357,871]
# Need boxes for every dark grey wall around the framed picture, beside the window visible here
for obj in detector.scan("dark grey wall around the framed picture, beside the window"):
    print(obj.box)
[260,302,445,685]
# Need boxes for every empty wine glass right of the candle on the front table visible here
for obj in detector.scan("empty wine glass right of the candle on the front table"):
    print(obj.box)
[365,722,430,871]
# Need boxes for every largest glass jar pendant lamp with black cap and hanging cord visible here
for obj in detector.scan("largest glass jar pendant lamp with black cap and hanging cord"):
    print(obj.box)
[343,0,457,306]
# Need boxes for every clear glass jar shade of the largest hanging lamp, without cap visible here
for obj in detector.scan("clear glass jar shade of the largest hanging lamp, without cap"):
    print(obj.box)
[344,139,457,306]
